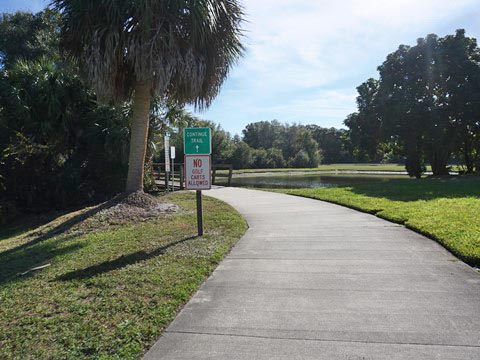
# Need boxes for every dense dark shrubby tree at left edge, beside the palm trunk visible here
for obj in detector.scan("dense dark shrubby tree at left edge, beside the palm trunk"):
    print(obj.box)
[0,58,128,210]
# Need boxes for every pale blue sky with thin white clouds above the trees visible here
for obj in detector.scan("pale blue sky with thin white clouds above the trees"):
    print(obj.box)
[0,0,480,135]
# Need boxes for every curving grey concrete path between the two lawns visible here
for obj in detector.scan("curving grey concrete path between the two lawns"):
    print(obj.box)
[145,188,480,360]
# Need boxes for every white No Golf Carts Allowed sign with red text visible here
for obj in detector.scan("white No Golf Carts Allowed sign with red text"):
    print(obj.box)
[185,155,212,190]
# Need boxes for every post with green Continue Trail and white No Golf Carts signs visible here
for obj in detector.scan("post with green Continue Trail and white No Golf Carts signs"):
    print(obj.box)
[183,128,212,236]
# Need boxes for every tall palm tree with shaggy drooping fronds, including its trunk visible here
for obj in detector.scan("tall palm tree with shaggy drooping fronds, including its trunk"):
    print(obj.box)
[52,0,243,192]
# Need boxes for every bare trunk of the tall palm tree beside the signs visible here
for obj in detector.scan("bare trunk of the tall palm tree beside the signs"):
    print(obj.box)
[125,82,152,193]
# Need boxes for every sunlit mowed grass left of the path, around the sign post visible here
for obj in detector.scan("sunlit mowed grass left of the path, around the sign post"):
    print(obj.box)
[0,193,247,359]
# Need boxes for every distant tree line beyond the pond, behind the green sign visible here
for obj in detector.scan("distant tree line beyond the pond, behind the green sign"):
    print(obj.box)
[163,117,355,169]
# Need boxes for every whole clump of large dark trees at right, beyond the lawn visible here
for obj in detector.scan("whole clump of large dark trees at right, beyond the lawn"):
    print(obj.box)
[345,30,480,177]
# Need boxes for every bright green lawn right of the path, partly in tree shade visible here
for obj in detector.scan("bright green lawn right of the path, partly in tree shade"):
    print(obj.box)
[274,177,480,267]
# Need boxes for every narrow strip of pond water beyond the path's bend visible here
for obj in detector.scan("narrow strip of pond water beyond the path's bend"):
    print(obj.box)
[218,174,408,189]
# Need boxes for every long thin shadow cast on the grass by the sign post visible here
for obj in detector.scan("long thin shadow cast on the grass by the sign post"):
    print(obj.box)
[56,236,198,281]
